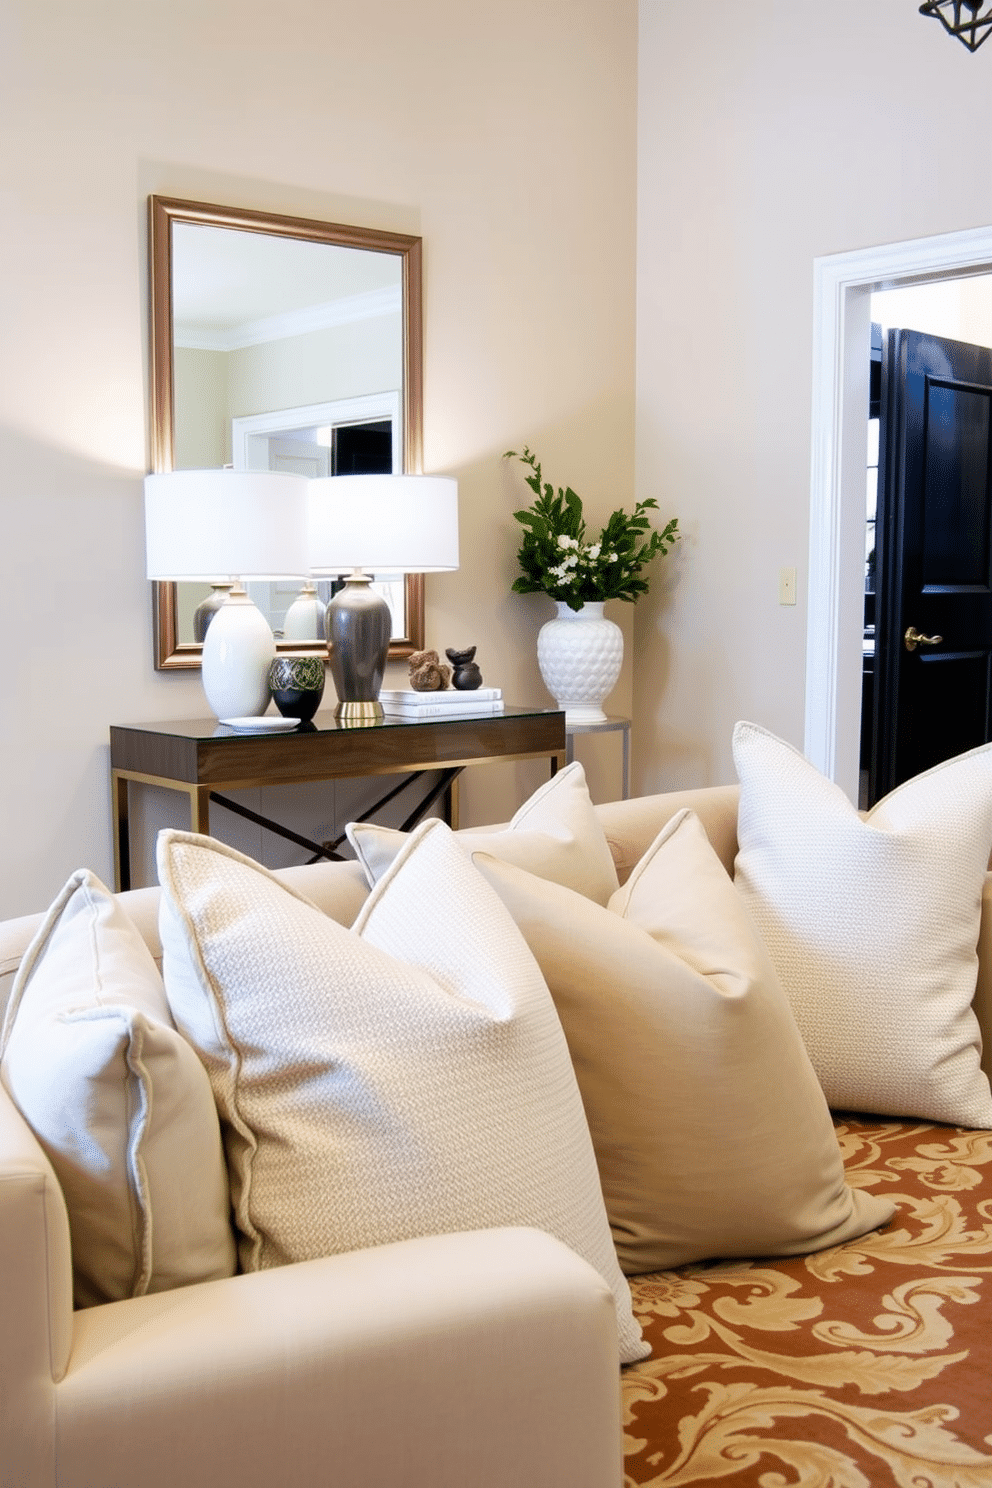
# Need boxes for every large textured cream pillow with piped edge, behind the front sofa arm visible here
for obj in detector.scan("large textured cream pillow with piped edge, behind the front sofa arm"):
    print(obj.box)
[158,821,647,1362]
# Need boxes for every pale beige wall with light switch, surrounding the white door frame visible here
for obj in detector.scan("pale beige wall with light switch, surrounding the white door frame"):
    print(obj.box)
[634,0,992,790]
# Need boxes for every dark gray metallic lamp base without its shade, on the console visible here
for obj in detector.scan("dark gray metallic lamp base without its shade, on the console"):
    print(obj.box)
[326,573,393,723]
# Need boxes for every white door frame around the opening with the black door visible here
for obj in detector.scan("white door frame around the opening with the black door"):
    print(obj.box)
[805,226,992,802]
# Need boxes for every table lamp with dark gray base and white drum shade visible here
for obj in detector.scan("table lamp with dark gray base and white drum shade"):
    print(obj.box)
[308,475,458,723]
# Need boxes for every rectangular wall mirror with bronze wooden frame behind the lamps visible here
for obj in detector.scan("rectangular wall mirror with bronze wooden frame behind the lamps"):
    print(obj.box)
[149,196,424,668]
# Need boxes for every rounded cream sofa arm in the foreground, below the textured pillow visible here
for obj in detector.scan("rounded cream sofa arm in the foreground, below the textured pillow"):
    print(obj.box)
[52,1229,622,1488]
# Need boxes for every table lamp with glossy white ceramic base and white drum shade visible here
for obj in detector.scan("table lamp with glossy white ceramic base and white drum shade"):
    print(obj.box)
[144,470,306,719]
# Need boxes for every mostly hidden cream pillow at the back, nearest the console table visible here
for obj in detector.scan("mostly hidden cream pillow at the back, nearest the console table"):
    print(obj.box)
[347,760,619,905]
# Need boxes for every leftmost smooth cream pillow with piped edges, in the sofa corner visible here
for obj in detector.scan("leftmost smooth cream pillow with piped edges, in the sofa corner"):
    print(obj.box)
[0,870,235,1306]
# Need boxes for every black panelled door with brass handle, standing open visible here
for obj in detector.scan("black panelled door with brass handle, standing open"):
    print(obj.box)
[869,330,992,802]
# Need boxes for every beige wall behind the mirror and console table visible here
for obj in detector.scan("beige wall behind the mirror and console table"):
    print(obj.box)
[0,0,637,915]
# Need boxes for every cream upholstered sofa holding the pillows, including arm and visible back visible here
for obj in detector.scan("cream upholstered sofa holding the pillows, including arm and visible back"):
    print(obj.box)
[0,787,992,1488]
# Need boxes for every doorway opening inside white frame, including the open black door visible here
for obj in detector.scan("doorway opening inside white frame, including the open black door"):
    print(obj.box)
[858,288,992,806]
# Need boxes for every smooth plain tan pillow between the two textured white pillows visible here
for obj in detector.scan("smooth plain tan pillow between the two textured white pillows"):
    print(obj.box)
[474,811,894,1274]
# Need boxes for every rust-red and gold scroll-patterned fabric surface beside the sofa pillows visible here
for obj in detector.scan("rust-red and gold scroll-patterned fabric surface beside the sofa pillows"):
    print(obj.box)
[623,1116,992,1488]
